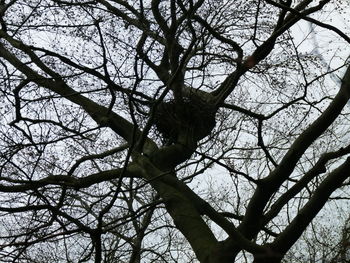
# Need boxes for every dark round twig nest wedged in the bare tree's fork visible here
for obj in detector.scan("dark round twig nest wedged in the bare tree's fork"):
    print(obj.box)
[154,96,216,142]
